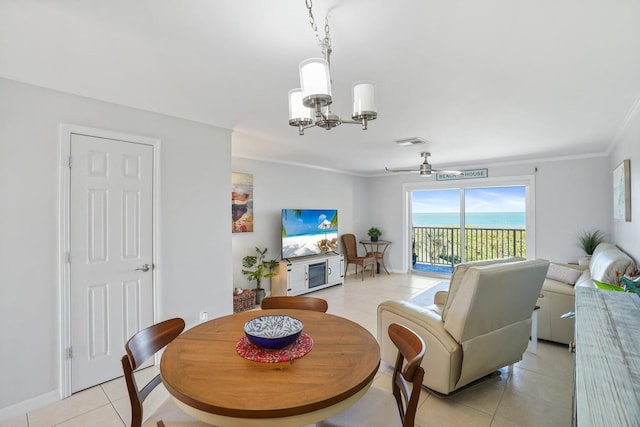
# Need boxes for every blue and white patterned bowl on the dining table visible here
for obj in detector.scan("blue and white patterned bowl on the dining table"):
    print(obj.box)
[244,315,303,350]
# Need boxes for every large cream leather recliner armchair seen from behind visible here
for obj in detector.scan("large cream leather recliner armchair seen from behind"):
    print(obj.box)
[378,259,549,394]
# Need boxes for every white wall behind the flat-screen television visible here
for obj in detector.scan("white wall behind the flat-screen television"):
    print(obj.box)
[232,153,368,291]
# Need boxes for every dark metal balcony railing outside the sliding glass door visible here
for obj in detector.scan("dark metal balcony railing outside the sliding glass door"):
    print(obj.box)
[413,227,527,267]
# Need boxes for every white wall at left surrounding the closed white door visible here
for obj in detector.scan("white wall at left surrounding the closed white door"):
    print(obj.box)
[0,79,232,419]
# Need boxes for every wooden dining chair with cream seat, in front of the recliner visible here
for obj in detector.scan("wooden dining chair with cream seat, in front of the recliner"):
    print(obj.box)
[317,323,426,427]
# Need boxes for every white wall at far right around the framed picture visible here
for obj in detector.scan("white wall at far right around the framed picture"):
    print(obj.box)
[607,106,640,262]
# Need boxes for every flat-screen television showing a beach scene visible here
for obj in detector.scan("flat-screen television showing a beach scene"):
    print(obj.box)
[281,209,338,259]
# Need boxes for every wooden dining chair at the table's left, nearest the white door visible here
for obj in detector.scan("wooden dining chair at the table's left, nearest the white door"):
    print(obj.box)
[122,318,211,427]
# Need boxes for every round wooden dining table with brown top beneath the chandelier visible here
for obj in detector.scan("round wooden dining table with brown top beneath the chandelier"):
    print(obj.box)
[160,309,380,427]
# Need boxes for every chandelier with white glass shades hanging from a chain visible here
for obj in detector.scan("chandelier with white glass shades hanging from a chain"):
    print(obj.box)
[289,0,378,135]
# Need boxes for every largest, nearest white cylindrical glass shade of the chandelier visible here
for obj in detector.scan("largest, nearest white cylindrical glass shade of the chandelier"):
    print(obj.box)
[300,58,331,108]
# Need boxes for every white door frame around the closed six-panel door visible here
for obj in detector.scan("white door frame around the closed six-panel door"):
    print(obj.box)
[57,123,161,399]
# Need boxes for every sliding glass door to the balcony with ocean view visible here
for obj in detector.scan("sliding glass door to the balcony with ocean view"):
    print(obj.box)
[409,185,527,273]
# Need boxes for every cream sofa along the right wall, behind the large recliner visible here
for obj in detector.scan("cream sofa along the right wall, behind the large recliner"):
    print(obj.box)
[536,243,636,344]
